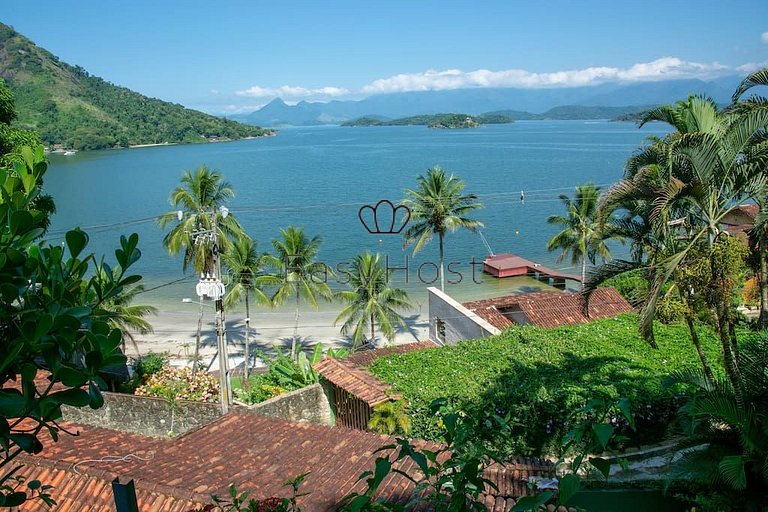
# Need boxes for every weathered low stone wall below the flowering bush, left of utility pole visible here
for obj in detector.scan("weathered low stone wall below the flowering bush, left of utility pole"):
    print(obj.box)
[62,392,221,437]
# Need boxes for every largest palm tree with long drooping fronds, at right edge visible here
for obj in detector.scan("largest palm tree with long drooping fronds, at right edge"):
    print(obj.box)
[585,88,768,397]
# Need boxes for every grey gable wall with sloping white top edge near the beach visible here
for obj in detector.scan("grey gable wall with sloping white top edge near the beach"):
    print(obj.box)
[427,287,501,345]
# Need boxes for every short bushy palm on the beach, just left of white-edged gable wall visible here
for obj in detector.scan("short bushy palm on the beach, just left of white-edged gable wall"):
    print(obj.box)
[334,252,413,348]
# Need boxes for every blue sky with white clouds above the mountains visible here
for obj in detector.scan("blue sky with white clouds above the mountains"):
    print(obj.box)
[0,0,768,113]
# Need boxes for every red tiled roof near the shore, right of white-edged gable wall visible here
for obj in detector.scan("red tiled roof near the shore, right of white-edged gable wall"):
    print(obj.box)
[464,288,632,329]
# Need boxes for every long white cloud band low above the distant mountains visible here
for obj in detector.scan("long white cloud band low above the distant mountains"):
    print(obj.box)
[362,57,730,94]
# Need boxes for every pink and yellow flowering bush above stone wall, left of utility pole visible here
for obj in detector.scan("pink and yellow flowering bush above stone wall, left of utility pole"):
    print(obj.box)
[136,366,219,402]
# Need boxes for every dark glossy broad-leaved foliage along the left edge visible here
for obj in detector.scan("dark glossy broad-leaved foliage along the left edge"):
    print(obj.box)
[0,143,141,505]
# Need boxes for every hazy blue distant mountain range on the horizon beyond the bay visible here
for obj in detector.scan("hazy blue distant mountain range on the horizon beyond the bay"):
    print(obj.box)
[232,76,743,127]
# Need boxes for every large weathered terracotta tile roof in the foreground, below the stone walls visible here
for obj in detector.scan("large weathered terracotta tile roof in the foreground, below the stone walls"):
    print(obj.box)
[20,413,552,512]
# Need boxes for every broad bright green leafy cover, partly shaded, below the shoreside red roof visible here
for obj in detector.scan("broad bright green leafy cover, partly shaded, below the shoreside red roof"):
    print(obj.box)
[370,314,717,454]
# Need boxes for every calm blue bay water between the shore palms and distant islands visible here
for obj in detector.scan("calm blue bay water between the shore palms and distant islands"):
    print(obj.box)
[45,121,664,309]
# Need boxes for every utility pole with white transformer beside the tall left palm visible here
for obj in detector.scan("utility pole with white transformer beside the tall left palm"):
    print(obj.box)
[179,206,232,414]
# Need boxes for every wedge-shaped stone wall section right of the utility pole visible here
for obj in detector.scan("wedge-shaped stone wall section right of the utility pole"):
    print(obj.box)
[246,384,333,426]
